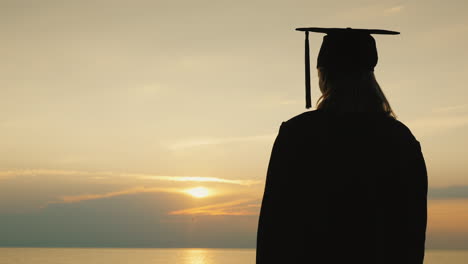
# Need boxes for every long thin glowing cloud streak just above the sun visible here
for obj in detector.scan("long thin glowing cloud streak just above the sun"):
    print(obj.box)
[0,169,262,186]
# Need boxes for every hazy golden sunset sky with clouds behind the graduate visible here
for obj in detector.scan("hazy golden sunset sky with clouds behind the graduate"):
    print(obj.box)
[0,0,468,249]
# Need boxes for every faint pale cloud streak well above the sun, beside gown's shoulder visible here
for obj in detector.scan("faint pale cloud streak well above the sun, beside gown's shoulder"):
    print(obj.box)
[168,134,276,150]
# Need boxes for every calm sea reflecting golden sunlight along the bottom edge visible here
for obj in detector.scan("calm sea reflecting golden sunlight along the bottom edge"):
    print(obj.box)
[0,248,468,264]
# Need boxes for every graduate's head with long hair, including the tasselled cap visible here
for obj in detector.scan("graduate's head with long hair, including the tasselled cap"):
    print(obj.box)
[296,27,400,114]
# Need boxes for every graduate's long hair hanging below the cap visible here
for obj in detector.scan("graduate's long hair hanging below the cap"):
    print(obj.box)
[317,68,396,118]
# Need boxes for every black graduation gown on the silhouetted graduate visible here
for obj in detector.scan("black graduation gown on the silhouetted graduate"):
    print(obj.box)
[256,110,427,264]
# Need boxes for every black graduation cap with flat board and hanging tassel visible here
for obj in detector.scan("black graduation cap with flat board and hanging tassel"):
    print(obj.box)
[296,27,400,108]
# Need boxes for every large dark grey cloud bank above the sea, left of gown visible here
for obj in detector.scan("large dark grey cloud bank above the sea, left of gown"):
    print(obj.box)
[0,192,258,248]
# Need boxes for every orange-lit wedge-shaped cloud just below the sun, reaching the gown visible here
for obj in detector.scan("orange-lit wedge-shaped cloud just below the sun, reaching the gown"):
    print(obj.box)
[169,199,260,216]
